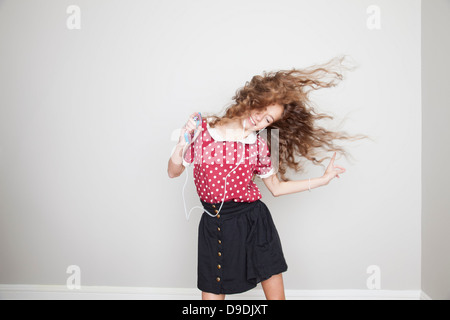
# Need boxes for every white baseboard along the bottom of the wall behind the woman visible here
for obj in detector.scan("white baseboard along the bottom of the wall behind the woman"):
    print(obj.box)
[0,285,431,300]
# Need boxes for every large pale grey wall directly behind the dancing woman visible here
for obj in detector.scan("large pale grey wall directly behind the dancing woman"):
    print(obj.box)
[0,0,421,290]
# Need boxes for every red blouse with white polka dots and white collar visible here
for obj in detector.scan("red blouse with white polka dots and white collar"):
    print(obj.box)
[183,119,275,203]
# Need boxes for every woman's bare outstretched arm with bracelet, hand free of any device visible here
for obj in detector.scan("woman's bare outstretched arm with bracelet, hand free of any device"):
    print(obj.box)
[262,152,345,197]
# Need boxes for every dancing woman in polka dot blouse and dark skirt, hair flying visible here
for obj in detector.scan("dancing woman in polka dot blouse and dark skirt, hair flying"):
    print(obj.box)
[168,57,363,300]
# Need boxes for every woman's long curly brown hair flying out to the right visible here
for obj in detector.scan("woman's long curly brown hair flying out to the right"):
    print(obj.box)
[206,55,370,181]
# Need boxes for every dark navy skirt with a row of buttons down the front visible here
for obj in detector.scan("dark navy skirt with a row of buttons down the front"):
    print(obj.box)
[197,200,287,294]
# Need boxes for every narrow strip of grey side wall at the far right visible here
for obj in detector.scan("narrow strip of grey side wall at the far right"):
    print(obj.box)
[422,0,450,299]
